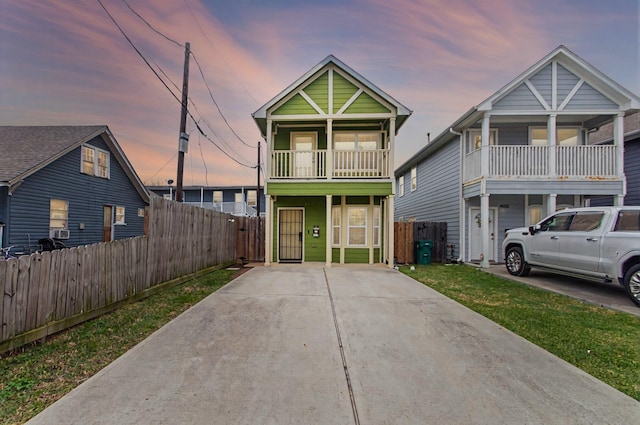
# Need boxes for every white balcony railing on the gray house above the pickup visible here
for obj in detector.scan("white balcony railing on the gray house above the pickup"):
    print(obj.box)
[464,145,618,181]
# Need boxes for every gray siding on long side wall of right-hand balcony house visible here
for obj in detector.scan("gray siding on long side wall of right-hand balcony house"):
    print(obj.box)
[395,139,460,247]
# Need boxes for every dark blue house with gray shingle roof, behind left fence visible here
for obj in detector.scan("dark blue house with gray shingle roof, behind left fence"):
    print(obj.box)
[0,125,149,252]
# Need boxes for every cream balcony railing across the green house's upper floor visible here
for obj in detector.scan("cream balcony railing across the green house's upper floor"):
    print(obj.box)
[267,149,391,180]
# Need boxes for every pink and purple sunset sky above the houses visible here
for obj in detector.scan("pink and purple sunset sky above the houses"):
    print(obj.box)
[0,0,640,186]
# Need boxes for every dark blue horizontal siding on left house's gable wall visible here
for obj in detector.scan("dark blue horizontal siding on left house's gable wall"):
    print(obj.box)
[7,137,147,247]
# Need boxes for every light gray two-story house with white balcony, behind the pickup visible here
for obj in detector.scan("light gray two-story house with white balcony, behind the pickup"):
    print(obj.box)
[395,46,640,267]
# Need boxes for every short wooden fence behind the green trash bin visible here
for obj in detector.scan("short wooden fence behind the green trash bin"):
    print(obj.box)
[393,221,447,264]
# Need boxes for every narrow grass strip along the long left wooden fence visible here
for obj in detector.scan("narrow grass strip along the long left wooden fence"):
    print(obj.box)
[0,270,238,425]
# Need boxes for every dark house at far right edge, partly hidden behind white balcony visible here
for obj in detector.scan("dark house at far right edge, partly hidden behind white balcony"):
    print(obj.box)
[589,112,640,207]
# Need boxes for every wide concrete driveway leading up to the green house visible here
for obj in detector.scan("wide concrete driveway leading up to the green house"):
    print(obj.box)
[29,265,640,425]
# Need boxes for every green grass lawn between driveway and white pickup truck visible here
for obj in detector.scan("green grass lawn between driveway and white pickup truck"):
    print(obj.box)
[400,264,640,401]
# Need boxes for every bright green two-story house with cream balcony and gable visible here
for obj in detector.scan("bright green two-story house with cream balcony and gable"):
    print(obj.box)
[253,55,411,267]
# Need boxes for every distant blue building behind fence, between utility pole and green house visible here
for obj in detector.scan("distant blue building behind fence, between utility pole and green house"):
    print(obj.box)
[147,186,266,217]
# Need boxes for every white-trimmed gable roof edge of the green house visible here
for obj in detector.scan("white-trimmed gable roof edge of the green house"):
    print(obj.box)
[251,55,412,135]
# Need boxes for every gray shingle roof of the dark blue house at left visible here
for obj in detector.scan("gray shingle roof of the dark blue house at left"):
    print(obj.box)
[0,125,149,202]
